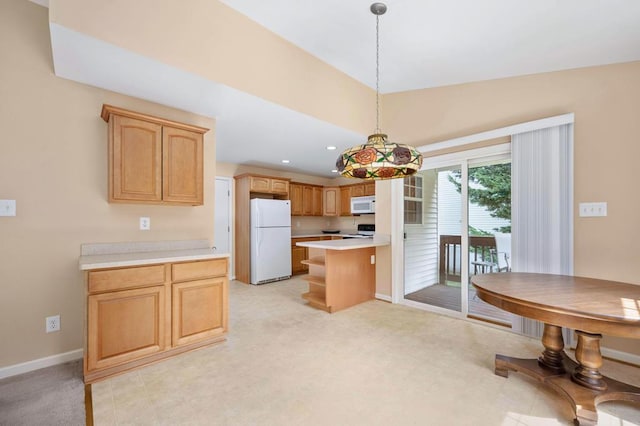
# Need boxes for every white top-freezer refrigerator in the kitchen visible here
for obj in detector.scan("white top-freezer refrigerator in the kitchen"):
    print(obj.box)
[251,198,291,284]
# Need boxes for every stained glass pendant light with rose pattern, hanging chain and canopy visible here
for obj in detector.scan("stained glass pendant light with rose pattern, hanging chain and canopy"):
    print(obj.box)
[336,3,422,180]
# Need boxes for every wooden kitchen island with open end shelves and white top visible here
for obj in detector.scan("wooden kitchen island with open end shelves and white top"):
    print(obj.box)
[297,235,390,313]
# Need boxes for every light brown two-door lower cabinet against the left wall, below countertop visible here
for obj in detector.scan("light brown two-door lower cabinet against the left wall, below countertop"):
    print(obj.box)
[84,258,229,383]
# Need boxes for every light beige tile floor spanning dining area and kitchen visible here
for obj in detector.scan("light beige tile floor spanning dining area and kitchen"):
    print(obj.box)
[93,279,640,426]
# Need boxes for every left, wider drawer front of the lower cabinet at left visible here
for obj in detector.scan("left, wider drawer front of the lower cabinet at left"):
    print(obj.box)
[89,265,166,293]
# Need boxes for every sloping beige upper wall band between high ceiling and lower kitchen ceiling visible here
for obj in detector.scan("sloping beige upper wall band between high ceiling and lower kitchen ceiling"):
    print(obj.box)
[49,0,375,133]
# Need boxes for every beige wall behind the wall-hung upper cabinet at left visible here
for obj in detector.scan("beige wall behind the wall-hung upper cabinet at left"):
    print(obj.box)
[0,0,216,367]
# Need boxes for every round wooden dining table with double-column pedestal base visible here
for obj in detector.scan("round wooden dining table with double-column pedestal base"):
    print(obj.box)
[471,272,640,425]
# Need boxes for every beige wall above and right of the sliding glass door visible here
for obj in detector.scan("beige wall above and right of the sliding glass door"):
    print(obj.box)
[382,62,640,353]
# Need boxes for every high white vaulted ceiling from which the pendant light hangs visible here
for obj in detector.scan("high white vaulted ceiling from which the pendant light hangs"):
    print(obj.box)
[220,0,640,93]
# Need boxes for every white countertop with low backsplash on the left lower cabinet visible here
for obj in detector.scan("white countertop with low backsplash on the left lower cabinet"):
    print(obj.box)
[78,240,229,271]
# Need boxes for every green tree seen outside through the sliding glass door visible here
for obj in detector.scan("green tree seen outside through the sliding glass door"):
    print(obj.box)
[449,163,511,232]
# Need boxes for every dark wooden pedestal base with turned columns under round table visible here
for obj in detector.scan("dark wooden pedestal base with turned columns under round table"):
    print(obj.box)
[495,324,640,425]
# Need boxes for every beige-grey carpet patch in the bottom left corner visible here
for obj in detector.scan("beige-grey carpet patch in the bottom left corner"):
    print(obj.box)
[0,360,85,426]
